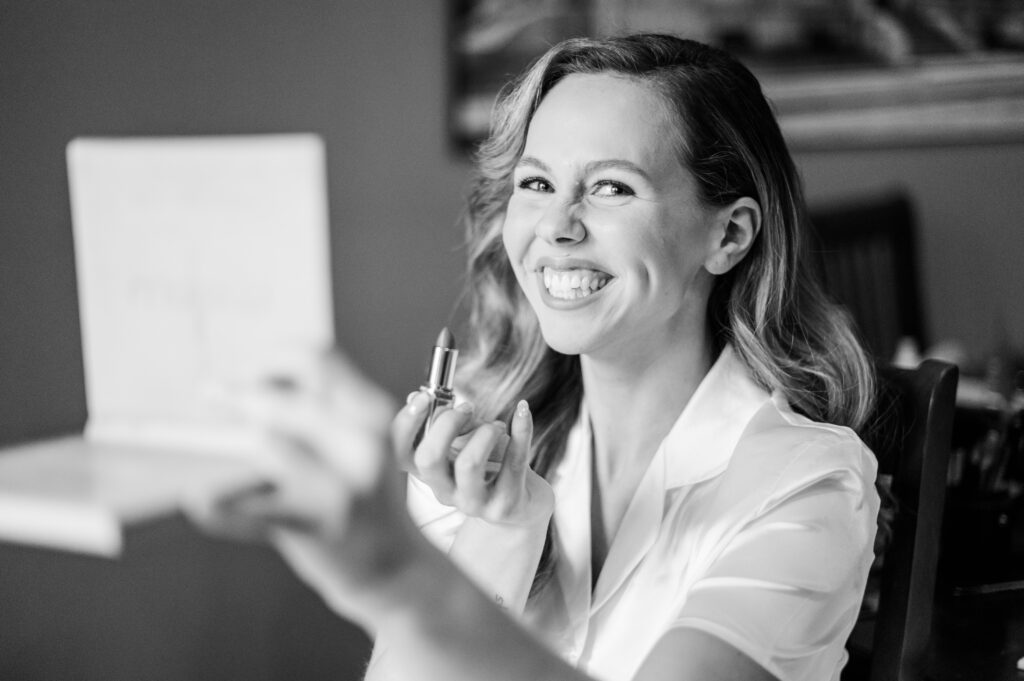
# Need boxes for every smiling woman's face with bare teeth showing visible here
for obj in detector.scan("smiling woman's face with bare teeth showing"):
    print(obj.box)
[503,74,712,357]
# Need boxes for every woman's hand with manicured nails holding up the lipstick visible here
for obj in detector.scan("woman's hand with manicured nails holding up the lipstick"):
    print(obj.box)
[391,391,554,524]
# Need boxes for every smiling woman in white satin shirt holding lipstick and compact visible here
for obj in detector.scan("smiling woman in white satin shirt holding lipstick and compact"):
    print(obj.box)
[196,35,878,681]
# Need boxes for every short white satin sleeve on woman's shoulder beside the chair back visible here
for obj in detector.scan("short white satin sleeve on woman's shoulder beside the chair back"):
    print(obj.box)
[675,440,879,681]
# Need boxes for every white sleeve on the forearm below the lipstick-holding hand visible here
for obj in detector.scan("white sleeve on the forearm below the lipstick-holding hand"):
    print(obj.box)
[409,475,550,616]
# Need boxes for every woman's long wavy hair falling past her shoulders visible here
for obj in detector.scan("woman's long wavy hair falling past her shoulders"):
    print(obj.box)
[459,34,874,593]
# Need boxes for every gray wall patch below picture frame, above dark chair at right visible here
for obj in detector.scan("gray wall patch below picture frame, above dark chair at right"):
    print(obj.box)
[797,142,1024,358]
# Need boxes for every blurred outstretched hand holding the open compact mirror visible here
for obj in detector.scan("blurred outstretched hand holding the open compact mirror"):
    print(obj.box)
[186,354,425,623]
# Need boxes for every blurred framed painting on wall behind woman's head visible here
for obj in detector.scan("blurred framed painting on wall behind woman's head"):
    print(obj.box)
[447,0,1024,151]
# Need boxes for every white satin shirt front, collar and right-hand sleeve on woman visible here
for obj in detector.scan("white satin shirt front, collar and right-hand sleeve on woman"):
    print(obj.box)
[411,347,879,681]
